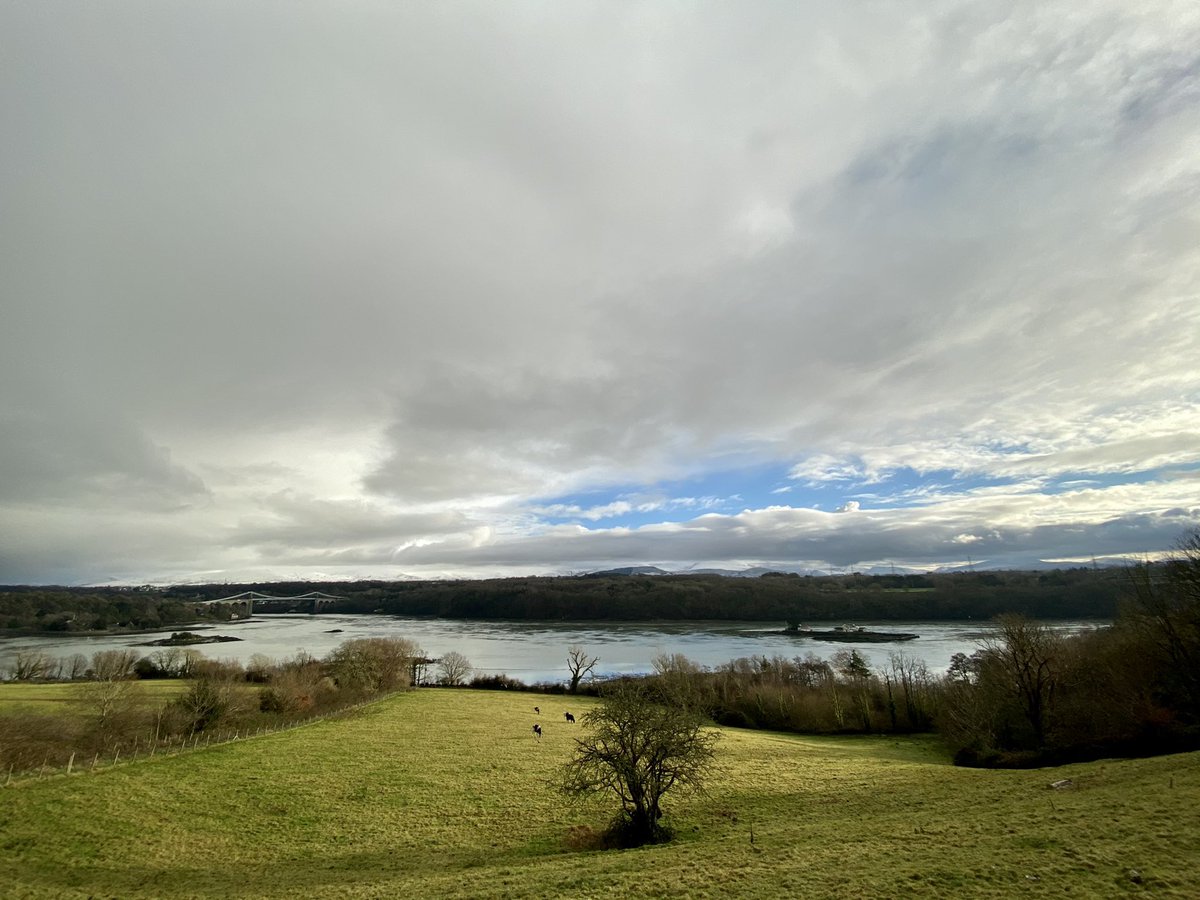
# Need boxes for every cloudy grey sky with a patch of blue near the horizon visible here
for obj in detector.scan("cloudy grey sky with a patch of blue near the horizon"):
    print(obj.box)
[0,0,1200,584]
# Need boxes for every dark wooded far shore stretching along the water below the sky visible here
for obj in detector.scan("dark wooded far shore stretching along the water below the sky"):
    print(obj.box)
[0,568,1132,632]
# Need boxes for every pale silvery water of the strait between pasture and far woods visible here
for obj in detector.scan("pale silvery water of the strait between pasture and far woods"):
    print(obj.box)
[0,614,1106,683]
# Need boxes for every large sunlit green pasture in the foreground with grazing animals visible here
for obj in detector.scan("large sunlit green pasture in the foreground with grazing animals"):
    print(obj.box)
[0,690,1200,898]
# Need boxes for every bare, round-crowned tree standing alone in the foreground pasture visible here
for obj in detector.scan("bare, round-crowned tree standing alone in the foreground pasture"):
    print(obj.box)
[560,682,716,847]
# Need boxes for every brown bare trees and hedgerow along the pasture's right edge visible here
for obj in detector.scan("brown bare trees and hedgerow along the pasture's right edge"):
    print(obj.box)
[573,532,1200,767]
